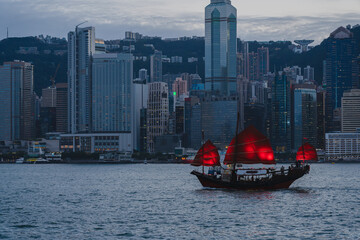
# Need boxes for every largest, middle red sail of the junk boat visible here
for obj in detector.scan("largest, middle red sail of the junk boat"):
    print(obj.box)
[224,126,276,165]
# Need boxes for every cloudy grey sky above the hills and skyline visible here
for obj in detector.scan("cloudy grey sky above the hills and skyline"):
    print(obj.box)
[0,0,360,43]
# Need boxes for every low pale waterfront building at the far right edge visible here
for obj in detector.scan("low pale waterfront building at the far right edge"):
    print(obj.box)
[325,132,360,161]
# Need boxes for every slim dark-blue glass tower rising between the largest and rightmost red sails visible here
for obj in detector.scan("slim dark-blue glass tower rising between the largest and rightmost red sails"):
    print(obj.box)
[271,72,291,152]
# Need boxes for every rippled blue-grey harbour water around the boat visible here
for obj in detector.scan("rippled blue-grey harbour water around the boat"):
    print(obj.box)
[0,164,360,240]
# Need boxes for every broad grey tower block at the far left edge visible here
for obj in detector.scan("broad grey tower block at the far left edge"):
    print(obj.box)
[0,61,36,141]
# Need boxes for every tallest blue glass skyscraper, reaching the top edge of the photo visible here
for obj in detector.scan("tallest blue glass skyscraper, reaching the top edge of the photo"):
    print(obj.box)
[205,0,237,95]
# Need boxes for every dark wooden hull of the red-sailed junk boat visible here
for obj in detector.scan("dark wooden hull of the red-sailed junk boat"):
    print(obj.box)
[191,166,310,190]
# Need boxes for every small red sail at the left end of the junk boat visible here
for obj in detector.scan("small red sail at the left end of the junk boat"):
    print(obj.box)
[191,140,221,167]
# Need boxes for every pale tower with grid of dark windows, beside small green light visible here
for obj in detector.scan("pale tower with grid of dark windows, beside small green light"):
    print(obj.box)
[146,82,169,152]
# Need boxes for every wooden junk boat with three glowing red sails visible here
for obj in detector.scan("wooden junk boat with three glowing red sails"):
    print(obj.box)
[191,126,317,190]
